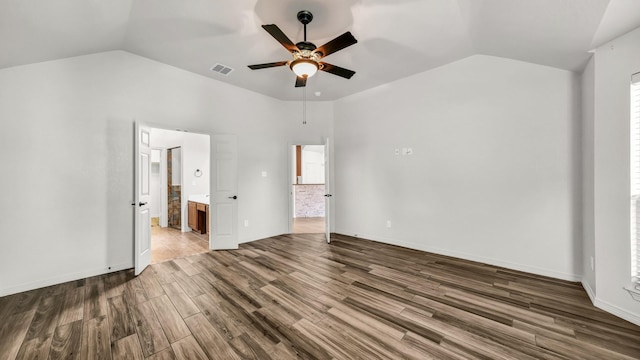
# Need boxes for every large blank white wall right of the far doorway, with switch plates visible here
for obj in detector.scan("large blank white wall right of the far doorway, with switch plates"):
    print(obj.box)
[333,55,582,280]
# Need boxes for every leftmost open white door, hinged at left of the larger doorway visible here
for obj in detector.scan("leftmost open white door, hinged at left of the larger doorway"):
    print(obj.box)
[133,122,151,276]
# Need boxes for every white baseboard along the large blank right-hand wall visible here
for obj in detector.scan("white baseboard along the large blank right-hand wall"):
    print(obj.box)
[335,229,582,282]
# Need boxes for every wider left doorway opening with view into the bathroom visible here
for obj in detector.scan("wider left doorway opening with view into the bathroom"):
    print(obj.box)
[150,128,211,263]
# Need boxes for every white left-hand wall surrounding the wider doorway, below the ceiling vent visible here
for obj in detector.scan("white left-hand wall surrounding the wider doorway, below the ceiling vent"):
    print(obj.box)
[0,51,332,296]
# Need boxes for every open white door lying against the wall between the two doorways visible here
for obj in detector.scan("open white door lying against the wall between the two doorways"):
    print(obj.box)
[209,135,238,250]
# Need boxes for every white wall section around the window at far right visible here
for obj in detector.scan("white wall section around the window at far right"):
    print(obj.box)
[589,25,640,324]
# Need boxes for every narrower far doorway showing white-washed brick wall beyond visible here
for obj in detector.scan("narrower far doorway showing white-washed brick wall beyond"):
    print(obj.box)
[290,145,326,234]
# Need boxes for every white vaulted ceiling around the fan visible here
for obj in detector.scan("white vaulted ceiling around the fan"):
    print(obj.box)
[0,0,640,100]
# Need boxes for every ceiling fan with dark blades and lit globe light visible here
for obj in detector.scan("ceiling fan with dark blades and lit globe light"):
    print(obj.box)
[249,10,358,87]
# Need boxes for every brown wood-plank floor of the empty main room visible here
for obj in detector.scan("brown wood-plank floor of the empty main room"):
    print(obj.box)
[0,234,640,360]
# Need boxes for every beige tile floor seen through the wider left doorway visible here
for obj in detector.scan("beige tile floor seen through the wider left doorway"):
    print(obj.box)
[151,226,209,264]
